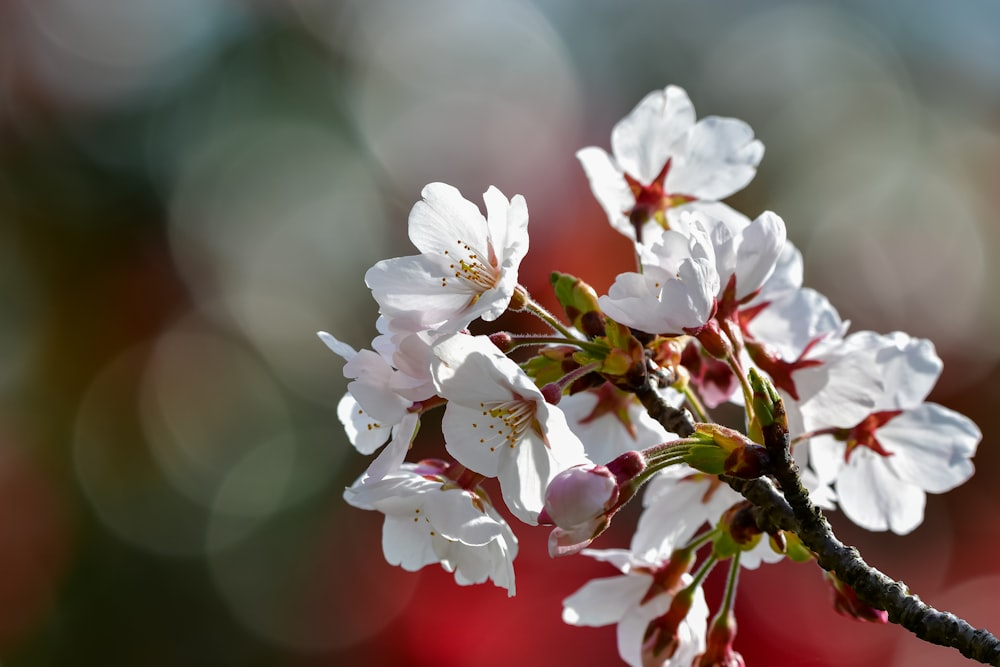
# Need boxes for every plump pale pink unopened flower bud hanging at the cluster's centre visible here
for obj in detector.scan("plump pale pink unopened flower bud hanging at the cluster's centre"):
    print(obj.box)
[539,465,618,529]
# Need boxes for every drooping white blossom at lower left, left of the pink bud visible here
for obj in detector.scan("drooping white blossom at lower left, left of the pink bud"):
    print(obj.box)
[344,462,517,595]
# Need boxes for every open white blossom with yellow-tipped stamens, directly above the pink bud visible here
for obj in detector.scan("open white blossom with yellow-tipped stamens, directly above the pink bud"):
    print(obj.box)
[432,334,589,524]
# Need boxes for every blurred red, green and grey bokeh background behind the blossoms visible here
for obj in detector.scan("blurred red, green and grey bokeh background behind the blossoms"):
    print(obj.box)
[0,0,1000,667]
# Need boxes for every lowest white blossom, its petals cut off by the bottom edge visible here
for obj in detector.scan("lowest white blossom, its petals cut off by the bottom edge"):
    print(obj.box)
[563,549,708,667]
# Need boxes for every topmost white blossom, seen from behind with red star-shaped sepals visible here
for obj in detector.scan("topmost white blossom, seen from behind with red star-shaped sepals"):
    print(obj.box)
[577,86,764,244]
